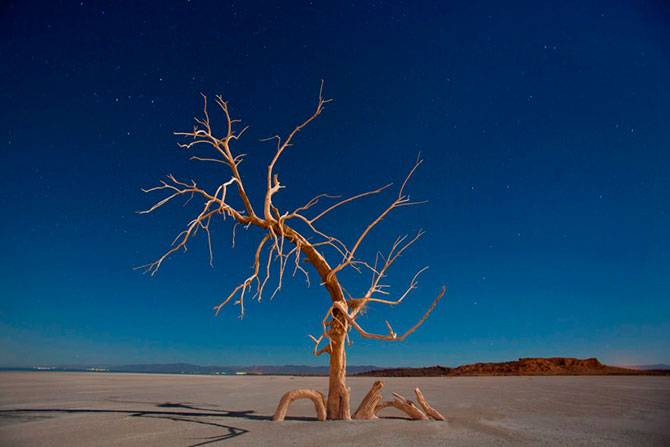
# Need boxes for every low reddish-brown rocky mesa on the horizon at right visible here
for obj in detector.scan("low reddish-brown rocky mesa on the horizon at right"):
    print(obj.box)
[357,357,670,377]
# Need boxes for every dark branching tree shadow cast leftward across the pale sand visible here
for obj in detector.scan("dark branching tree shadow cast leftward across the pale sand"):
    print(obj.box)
[0,401,316,447]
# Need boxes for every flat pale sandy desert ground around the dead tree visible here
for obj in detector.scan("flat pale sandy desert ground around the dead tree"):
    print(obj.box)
[0,372,670,447]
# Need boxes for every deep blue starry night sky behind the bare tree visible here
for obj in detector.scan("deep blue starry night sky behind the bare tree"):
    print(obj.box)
[0,0,670,366]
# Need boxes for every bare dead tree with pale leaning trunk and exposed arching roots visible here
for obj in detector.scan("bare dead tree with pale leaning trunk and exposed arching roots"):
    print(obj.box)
[140,82,444,419]
